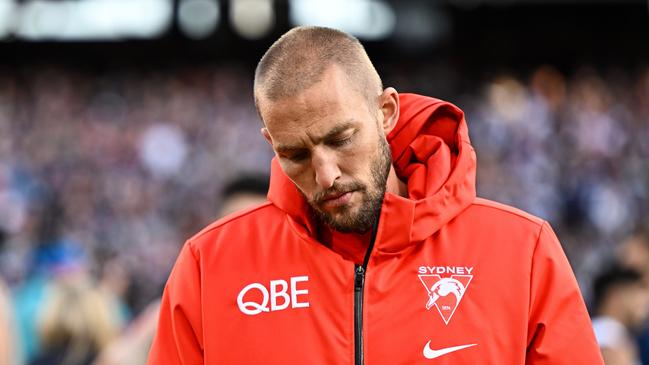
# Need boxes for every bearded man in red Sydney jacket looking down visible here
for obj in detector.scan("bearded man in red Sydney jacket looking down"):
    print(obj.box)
[149,27,602,365]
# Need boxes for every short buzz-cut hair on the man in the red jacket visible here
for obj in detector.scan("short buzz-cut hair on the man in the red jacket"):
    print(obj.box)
[254,26,383,115]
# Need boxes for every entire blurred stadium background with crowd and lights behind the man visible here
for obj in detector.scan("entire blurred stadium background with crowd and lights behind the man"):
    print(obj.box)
[0,0,649,365]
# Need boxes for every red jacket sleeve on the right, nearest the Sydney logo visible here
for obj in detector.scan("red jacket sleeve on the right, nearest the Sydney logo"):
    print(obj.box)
[526,223,604,365]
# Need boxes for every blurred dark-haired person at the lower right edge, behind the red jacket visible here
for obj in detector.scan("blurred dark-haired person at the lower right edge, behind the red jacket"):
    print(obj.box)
[593,267,649,365]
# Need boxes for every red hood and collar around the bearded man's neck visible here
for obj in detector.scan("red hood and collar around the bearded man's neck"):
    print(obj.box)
[268,94,476,253]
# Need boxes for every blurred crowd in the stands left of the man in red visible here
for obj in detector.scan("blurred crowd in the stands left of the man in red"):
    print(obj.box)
[0,67,272,364]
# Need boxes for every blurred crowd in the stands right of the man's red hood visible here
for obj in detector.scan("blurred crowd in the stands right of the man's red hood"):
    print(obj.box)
[459,66,649,276]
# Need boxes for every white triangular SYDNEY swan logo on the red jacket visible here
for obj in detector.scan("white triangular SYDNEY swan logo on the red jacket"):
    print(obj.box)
[418,266,473,325]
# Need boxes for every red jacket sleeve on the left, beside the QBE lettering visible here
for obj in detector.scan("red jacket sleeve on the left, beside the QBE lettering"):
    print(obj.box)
[147,242,203,365]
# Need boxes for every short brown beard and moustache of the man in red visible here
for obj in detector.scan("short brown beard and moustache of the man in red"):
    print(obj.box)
[307,136,392,233]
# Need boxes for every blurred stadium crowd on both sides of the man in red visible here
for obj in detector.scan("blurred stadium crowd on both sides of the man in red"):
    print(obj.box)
[0,65,649,365]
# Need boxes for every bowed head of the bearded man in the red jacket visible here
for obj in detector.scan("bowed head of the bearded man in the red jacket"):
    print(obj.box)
[254,27,399,233]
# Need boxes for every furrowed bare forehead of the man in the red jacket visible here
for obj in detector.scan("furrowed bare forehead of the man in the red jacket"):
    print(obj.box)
[260,66,369,139]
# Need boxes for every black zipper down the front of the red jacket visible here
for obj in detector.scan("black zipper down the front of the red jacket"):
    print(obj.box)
[354,218,379,365]
